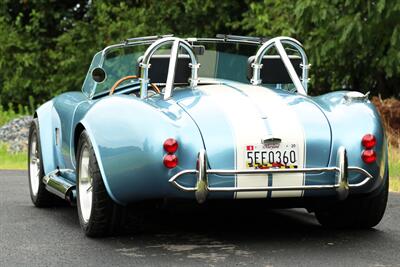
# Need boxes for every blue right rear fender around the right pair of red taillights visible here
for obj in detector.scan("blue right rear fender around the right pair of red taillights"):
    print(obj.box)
[317,91,387,192]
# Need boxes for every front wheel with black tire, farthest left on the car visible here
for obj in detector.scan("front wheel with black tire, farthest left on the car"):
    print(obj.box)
[28,118,59,208]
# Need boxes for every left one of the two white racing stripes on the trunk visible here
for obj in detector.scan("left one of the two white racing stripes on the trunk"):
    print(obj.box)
[200,85,268,198]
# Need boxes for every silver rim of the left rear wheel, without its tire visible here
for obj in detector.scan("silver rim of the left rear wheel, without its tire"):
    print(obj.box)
[78,146,93,223]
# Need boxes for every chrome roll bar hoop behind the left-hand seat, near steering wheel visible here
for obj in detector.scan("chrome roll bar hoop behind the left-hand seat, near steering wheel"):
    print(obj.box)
[139,37,200,100]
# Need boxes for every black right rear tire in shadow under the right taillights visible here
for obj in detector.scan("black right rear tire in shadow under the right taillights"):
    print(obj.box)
[315,171,389,229]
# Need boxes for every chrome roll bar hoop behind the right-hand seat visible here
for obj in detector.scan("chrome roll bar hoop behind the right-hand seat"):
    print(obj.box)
[250,36,310,95]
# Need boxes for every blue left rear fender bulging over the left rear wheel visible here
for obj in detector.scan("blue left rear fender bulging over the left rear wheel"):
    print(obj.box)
[81,95,204,204]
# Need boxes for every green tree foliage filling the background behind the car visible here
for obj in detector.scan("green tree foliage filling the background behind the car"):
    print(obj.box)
[0,0,400,107]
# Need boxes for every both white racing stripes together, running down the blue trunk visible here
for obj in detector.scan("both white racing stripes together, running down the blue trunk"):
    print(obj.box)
[199,84,305,198]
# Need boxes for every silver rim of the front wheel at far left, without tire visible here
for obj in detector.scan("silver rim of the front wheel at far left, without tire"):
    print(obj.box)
[29,132,41,196]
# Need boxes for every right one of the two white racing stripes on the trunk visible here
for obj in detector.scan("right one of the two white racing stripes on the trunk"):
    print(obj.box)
[233,85,305,197]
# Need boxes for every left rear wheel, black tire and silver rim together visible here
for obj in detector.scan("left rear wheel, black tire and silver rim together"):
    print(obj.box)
[77,131,122,237]
